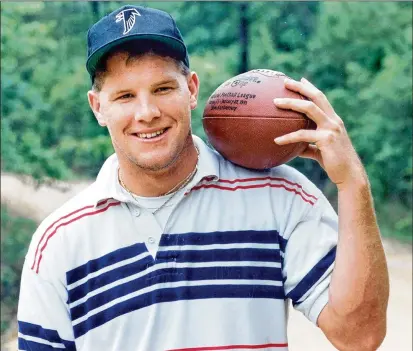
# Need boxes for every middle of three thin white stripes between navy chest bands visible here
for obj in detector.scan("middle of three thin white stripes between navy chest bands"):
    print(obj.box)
[69,261,281,308]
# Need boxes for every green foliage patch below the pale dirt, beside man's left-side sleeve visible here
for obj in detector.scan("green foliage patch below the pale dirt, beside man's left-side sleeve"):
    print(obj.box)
[1,205,36,334]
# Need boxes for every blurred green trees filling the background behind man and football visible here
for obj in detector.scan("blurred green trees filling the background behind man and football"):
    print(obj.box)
[1,1,413,336]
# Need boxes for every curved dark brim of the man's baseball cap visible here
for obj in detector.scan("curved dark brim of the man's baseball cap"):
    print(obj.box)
[86,34,188,77]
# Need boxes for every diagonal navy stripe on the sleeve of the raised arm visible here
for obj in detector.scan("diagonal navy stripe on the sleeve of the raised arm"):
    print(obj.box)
[287,246,337,305]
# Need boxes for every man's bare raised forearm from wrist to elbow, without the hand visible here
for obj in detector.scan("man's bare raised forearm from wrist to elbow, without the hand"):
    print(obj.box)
[319,176,389,351]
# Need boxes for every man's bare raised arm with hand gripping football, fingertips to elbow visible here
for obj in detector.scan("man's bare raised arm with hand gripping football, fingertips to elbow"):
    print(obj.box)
[274,78,389,351]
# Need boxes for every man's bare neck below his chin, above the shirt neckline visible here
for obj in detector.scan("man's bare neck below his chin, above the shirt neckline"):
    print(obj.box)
[119,137,198,197]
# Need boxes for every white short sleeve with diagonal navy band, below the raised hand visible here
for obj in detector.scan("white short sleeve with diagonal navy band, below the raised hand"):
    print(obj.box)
[283,194,338,324]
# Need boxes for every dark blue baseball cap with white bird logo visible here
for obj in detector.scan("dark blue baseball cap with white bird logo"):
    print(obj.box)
[86,5,189,80]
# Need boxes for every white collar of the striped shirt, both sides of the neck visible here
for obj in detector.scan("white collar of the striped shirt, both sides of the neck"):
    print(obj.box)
[94,135,219,206]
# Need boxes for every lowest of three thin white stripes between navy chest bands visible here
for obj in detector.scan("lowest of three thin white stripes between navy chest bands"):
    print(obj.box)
[73,279,283,326]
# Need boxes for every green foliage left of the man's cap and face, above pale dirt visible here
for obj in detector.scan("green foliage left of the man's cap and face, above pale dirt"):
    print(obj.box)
[1,3,104,180]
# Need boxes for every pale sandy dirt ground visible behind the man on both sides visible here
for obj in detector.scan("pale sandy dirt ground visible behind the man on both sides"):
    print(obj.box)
[1,174,412,351]
